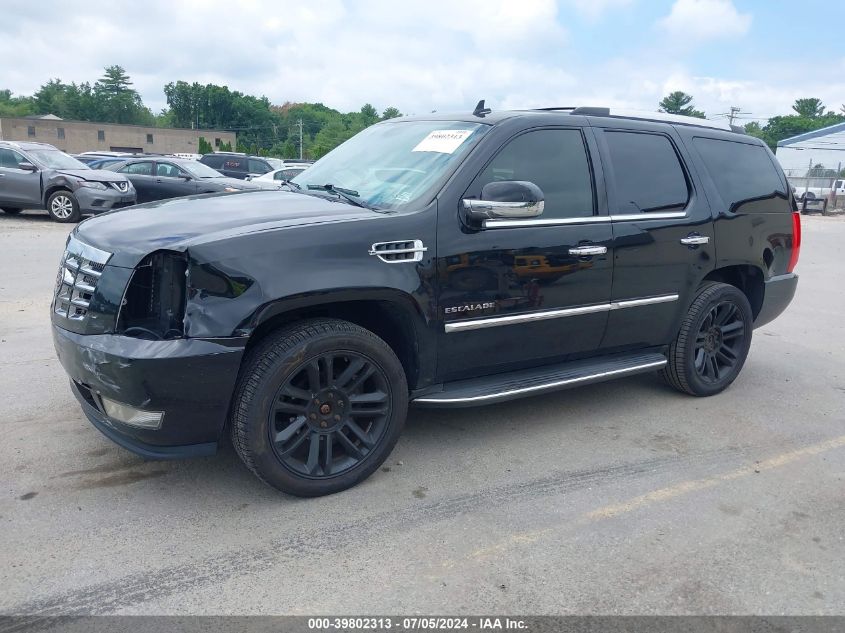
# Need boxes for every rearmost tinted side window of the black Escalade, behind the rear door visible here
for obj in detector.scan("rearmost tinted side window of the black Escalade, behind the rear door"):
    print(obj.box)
[693,136,786,210]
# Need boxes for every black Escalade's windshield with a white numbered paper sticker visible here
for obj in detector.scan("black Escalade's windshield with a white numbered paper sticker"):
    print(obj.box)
[293,121,487,209]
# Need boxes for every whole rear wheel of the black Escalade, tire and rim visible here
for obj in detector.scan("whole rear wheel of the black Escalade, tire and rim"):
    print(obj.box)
[660,282,754,396]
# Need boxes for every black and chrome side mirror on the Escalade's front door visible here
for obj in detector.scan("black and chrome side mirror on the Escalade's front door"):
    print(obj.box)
[463,180,545,227]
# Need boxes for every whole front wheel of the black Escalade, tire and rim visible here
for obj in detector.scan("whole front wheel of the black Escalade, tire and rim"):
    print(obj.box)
[232,319,408,497]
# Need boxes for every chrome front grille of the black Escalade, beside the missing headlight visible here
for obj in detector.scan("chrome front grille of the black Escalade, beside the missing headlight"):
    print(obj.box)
[53,235,111,321]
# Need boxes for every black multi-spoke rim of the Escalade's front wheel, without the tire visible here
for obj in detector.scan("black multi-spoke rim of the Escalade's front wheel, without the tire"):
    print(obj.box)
[267,350,392,479]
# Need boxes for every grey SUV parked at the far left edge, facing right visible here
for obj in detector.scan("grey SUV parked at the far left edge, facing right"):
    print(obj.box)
[0,141,136,222]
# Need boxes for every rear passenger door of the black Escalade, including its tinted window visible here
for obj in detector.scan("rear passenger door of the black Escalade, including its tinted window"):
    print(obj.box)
[594,120,716,349]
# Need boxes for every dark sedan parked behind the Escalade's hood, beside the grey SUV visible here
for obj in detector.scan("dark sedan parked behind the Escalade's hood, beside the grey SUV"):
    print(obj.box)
[106,156,261,202]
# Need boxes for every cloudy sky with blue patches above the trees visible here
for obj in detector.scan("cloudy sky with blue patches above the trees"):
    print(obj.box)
[0,0,845,122]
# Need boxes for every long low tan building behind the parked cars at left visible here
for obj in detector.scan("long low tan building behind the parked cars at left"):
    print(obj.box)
[0,115,237,154]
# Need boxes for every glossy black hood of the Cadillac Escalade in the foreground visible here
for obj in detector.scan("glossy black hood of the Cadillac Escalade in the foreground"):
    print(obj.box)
[75,188,381,268]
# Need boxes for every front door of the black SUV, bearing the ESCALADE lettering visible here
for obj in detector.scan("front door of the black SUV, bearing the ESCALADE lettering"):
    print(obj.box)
[437,128,613,380]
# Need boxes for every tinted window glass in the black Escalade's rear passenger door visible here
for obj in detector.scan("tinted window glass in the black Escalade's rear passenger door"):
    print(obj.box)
[605,130,689,214]
